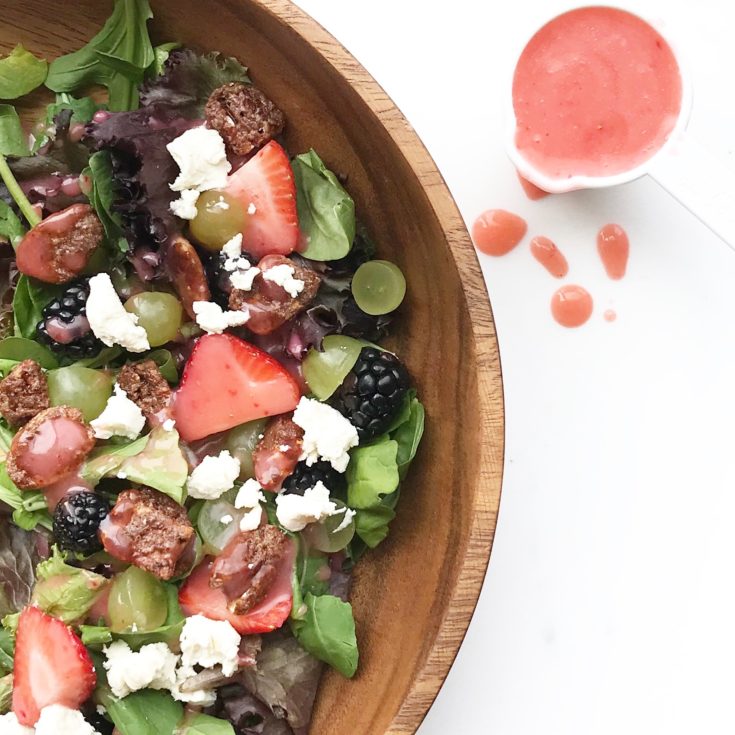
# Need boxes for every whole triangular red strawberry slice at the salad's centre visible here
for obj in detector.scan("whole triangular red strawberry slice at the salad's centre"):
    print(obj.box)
[173,334,301,441]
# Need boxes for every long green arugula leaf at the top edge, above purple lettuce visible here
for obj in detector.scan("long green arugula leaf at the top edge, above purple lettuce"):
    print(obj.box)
[46,0,155,111]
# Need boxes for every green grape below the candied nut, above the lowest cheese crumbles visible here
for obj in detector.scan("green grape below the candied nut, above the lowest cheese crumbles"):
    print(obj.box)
[107,567,168,633]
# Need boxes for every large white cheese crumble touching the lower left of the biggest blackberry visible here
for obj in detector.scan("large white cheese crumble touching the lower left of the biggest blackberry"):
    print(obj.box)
[293,397,359,472]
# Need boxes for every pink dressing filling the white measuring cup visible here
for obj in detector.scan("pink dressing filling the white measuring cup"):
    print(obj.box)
[513,7,682,179]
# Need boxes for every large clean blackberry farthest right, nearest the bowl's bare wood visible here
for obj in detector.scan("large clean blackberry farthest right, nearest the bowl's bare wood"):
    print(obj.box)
[335,347,408,441]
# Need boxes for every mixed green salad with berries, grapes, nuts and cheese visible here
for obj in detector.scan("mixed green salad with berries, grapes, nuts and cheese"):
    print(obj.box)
[0,0,424,735]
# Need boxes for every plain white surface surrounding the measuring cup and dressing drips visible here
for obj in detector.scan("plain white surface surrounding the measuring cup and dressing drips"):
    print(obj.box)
[299,0,735,735]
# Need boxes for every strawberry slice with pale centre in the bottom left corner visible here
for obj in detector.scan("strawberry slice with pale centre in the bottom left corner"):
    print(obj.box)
[13,607,97,727]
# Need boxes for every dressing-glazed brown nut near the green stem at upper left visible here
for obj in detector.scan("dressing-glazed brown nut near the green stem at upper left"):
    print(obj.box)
[16,204,104,283]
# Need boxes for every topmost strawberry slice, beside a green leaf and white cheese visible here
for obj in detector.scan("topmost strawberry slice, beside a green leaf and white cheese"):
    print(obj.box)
[226,141,299,258]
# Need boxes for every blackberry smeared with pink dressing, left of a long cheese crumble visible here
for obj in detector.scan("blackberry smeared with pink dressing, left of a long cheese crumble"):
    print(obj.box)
[36,278,102,360]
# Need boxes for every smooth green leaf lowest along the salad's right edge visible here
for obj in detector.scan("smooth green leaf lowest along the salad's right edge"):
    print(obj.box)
[291,592,358,678]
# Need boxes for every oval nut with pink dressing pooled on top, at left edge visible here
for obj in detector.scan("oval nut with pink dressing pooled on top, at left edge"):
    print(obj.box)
[6,406,95,490]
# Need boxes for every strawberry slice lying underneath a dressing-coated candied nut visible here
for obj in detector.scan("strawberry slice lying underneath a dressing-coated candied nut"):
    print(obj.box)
[179,541,296,635]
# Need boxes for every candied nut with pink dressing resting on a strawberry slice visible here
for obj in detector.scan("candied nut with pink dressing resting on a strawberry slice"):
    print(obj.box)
[209,526,288,615]
